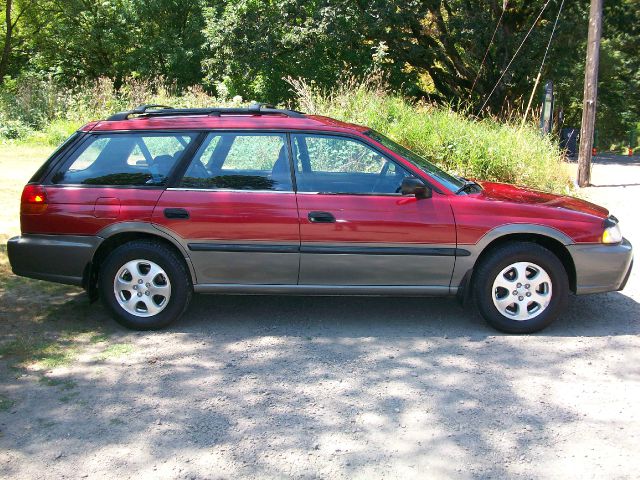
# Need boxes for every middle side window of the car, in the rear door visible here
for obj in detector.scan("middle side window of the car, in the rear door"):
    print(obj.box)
[180,132,292,191]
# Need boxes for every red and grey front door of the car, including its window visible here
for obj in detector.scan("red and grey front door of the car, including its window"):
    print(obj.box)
[291,134,456,287]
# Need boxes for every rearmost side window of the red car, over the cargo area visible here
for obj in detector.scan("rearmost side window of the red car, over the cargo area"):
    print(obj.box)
[52,132,196,186]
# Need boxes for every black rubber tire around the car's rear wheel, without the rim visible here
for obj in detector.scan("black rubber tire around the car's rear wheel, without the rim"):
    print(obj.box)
[98,241,192,330]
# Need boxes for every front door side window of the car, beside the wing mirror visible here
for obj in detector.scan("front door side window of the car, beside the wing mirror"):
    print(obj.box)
[292,135,409,194]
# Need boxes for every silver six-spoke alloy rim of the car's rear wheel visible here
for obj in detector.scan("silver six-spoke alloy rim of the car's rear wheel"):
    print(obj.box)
[113,259,171,317]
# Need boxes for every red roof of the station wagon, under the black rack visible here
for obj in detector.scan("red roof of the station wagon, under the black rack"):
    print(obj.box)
[80,114,369,133]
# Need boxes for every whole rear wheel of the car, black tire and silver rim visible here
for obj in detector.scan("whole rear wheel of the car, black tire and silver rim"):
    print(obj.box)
[98,240,193,330]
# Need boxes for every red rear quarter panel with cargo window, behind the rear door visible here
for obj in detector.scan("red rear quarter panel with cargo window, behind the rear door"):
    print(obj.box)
[42,132,197,235]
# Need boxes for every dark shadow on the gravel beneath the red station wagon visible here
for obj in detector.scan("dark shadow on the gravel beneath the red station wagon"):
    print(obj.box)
[169,292,640,337]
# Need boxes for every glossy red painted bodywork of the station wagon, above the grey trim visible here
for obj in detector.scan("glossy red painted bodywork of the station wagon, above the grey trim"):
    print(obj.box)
[21,115,608,245]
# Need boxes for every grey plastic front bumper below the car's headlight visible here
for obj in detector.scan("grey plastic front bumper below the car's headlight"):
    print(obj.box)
[567,238,633,295]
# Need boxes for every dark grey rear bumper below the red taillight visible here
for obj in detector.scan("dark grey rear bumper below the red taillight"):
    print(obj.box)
[7,235,102,286]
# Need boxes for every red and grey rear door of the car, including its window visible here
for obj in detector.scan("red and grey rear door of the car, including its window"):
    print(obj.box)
[153,132,300,284]
